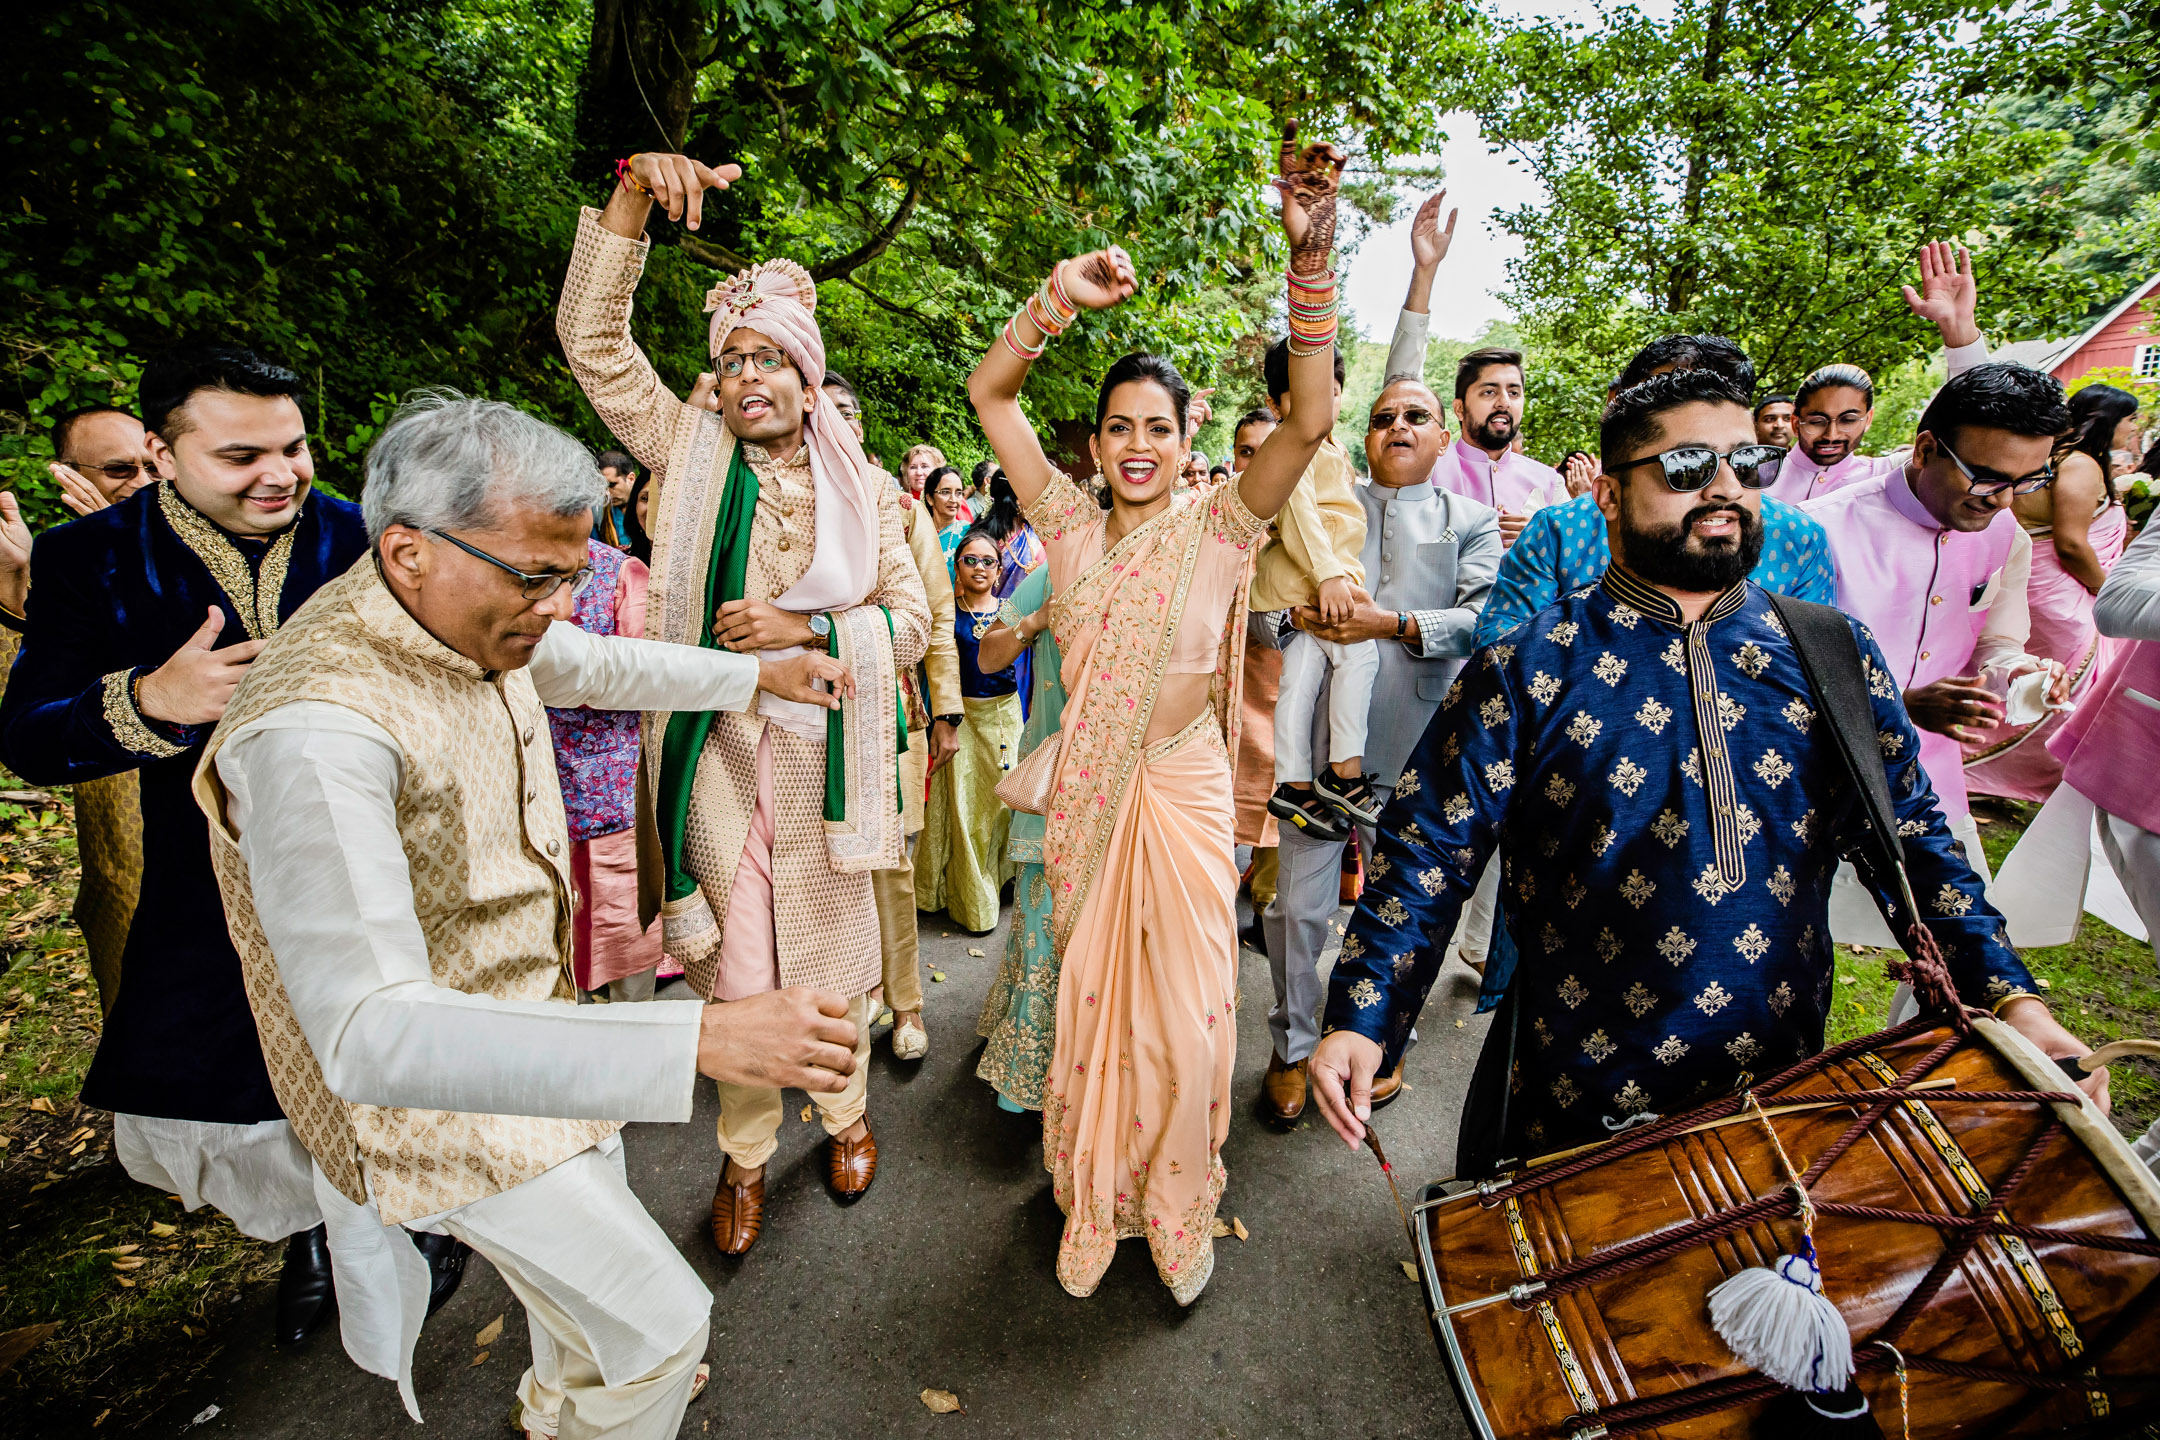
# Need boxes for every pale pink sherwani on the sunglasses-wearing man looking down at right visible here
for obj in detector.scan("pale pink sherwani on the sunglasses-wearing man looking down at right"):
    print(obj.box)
[1806,468,2033,823]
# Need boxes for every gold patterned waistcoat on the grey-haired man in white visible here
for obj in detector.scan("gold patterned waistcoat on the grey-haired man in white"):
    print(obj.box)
[194,555,618,1224]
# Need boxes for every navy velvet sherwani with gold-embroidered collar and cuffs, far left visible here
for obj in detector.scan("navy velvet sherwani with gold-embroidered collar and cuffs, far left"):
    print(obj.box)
[0,484,367,1125]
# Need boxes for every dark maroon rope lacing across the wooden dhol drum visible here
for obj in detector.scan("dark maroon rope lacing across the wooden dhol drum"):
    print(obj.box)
[1477,945,2160,1436]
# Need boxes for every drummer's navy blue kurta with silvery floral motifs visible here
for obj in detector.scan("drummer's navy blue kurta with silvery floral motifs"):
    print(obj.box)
[1326,568,2033,1155]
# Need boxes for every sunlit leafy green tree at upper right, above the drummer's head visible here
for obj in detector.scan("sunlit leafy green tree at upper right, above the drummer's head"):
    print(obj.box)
[1477,0,2095,453]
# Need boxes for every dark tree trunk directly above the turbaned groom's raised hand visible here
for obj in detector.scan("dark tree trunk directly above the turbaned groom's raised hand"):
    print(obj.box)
[577,0,713,181]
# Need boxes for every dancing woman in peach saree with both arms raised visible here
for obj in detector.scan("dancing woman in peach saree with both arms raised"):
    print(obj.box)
[968,138,1341,1304]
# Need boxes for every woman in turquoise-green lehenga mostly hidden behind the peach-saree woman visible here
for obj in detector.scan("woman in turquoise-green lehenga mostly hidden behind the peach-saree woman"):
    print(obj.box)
[974,566,1065,1114]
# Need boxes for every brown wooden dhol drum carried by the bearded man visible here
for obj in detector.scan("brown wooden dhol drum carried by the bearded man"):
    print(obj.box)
[1413,1015,2160,1440]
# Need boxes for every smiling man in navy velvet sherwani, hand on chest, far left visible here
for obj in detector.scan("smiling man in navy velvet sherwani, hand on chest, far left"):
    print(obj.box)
[0,345,380,1341]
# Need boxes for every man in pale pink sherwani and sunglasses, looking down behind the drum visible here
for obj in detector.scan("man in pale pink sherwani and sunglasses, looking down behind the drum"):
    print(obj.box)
[1804,365,2069,946]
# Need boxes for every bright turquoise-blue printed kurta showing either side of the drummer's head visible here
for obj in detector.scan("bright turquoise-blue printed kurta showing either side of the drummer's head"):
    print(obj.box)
[1477,494,1838,646]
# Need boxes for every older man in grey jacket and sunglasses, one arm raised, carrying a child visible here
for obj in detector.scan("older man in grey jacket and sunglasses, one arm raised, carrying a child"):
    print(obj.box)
[1261,227,1501,1123]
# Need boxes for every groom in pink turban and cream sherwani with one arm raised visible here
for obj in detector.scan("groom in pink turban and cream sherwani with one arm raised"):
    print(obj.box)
[555,143,931,1254]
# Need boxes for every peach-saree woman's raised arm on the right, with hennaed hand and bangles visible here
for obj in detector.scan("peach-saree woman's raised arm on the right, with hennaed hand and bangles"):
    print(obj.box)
[1238,125,1344,520]
